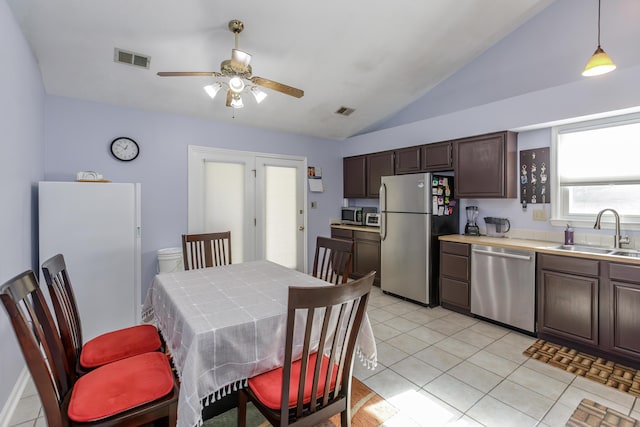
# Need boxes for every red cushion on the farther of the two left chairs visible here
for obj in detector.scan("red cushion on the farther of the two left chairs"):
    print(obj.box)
[80,325,162,369]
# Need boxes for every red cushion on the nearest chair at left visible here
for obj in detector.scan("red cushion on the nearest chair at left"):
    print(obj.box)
[67,352,174,422]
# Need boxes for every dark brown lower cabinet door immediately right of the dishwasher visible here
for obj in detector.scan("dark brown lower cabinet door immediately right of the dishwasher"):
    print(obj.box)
[538,270,599,346]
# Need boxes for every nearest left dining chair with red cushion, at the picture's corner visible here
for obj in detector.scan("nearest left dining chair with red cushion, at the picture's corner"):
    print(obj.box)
[0,270,178,427]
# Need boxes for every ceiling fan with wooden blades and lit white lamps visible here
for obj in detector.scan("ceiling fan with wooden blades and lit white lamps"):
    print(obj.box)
[158,19,304,108]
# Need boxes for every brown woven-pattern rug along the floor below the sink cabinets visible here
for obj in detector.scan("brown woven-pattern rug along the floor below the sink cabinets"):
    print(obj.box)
[523,339,640,398]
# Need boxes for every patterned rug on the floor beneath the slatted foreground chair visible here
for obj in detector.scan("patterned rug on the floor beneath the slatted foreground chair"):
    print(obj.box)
[203,378,398,427]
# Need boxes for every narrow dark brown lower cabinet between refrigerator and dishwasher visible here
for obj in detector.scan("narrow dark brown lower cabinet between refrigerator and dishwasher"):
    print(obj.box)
[440,242,471,314]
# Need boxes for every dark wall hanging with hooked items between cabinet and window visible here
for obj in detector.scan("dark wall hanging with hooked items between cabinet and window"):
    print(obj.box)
[518,147,551,206]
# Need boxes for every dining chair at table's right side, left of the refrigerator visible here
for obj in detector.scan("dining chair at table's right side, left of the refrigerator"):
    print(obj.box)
[312,236,353,285]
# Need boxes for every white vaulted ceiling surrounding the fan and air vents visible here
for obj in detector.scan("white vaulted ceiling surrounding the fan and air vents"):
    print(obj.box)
[8,0,552,140]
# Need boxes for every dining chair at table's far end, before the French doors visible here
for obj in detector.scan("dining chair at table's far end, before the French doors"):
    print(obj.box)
[182,231,231,270]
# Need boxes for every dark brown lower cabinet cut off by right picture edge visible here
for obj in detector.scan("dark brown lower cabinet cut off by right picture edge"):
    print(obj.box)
[609,263,640,359]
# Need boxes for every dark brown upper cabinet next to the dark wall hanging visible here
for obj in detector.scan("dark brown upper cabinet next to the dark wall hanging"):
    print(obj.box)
[453,131,518,199]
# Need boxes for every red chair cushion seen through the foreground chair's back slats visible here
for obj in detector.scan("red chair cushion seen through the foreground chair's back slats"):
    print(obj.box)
[248,353,338,409]
